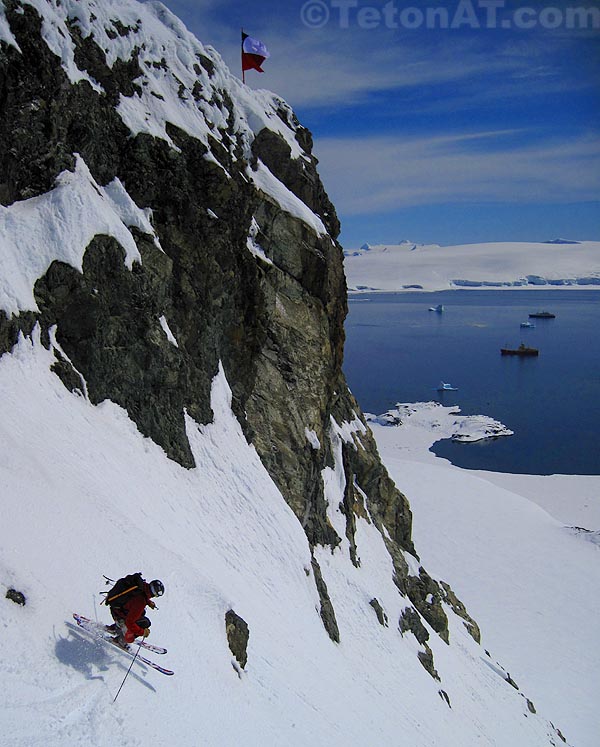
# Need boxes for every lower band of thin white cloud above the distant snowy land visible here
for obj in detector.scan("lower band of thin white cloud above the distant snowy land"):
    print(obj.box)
[317,131,600,215]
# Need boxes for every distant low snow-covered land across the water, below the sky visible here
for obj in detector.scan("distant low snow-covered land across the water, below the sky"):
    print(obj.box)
[344,240,600,292]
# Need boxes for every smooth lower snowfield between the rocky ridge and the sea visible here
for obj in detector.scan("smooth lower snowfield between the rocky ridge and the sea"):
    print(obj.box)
[371,403,600,747]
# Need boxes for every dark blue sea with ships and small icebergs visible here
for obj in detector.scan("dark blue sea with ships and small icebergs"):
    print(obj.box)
[344,290,600,475]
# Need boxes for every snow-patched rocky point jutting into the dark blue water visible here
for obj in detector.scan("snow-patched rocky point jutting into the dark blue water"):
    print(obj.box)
[365,402,514,448]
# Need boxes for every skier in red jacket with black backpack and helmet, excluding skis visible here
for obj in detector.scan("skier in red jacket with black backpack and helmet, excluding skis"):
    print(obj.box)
[104,573,165,647]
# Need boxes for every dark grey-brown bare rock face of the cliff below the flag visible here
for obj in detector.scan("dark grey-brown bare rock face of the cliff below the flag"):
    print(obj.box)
[0,0,476,673]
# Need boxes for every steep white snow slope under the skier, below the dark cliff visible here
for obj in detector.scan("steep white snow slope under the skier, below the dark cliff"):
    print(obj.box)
[0,334,568,747]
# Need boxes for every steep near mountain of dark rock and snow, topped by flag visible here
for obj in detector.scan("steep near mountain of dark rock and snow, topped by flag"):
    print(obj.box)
[0,0,600,747]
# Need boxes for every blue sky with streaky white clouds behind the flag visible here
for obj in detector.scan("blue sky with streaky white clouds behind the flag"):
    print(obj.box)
[158,0,600,248]
